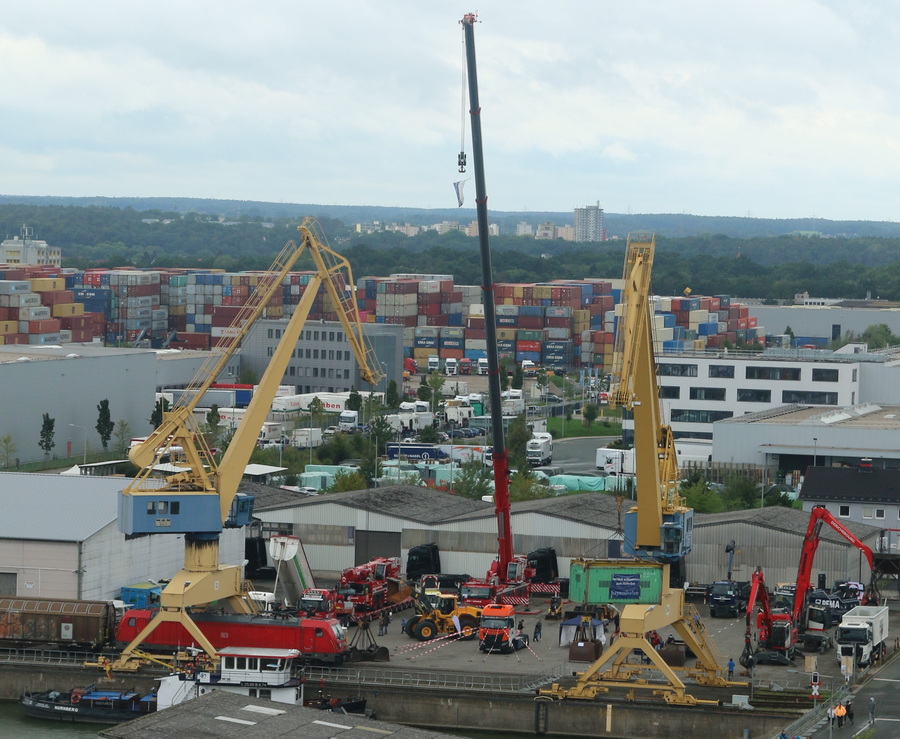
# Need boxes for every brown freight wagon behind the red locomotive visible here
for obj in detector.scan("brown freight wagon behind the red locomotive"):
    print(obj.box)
[0,598,124,649]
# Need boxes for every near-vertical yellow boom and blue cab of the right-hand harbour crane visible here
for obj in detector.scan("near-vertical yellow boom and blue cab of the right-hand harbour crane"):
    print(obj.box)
[609,233,693,562]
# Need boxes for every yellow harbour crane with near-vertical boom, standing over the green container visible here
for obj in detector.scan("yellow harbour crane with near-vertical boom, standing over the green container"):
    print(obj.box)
[541,233,727,705]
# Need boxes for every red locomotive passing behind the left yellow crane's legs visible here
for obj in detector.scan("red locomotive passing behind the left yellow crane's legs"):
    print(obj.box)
[117,609,347,665]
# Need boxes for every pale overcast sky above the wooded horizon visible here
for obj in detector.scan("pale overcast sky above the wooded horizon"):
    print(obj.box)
[0,0,900,221]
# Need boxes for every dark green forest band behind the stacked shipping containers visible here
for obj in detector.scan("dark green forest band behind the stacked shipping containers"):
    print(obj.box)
[0,203,900,300]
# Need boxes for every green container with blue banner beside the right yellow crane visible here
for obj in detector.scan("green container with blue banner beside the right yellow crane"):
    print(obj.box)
[569,559,663,606]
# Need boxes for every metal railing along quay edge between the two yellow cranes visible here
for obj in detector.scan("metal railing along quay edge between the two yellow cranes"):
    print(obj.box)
[305,664,569,693]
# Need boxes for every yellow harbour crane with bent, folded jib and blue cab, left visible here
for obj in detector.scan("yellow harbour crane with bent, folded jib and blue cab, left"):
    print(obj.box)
[114,218,381,668]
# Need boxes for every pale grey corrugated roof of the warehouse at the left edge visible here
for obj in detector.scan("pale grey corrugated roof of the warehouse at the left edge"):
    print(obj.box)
[0,472,128,541]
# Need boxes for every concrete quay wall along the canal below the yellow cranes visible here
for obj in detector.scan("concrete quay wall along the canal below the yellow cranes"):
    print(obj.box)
[0,664,798,739]
